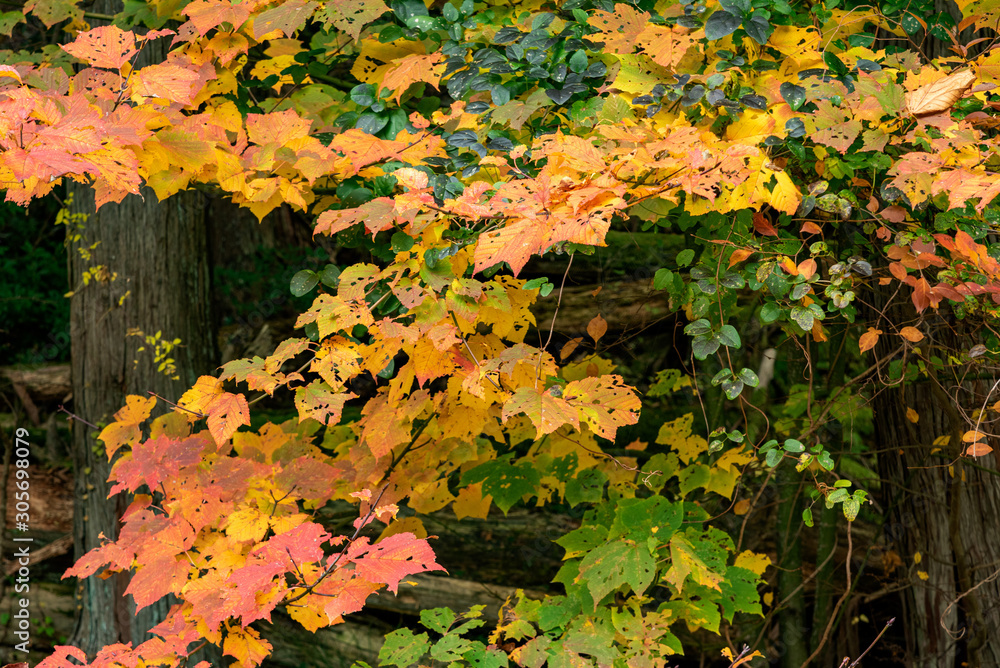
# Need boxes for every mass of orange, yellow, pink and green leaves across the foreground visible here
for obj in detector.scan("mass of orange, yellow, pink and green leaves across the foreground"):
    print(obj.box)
[0,0,1000,668]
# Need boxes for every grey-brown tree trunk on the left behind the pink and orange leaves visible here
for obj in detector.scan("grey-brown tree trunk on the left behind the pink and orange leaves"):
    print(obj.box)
[69,181,215,655]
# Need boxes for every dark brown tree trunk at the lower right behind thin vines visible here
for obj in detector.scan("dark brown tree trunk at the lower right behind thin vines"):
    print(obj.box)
[874,316,1000,668]
